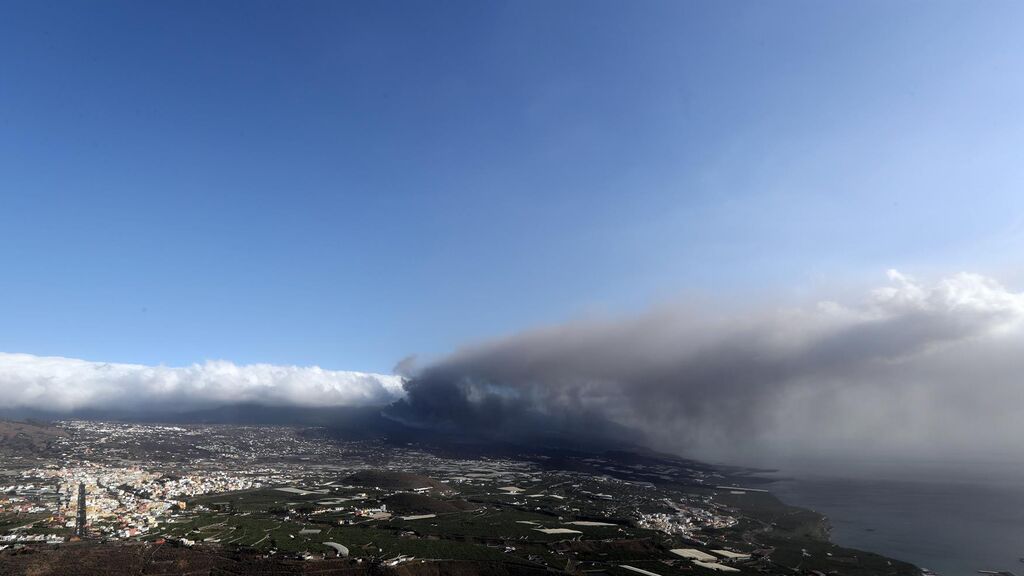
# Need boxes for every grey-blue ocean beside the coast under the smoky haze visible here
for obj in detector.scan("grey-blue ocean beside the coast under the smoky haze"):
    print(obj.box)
[770,466,1024,576]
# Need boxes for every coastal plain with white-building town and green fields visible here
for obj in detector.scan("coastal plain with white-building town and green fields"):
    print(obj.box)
[0,420,916,576]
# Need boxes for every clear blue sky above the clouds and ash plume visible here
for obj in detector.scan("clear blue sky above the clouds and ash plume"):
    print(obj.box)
[0,1,1024,371]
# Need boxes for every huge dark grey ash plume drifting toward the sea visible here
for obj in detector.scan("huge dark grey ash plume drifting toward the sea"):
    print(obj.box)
[389,271,1024,461]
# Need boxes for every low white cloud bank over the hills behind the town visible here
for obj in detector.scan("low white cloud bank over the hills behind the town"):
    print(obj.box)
[0,353,404,413]
